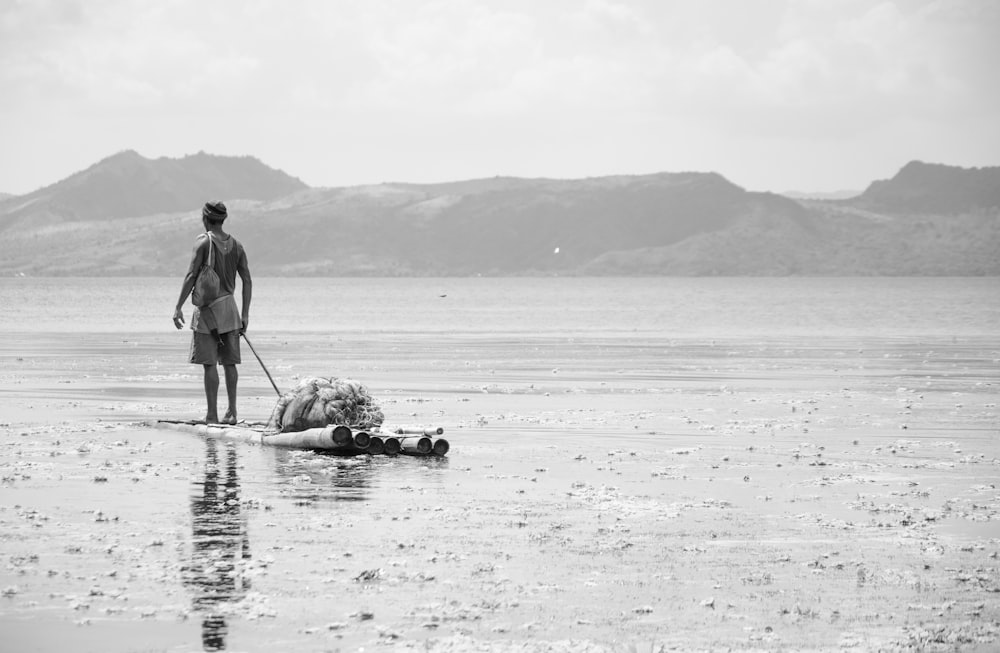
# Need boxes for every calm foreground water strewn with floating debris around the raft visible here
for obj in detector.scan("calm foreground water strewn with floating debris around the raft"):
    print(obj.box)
[0,331,1000,651]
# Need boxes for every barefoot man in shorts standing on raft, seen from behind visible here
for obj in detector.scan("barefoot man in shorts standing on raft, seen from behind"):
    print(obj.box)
[174,202,253,424]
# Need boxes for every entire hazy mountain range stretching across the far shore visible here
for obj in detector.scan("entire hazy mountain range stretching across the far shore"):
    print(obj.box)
[0,151,1000,276]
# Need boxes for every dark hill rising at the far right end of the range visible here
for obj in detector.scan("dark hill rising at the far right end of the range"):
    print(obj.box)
[850,161,1000,215]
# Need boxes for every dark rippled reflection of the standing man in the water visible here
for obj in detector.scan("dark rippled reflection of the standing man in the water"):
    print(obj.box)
[183,438,250,651]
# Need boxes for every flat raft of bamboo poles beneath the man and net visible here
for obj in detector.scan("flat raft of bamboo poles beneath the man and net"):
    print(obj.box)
[150,419,451,456]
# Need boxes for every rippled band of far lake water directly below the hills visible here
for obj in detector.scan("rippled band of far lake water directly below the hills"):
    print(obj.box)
[0,277,1000,339]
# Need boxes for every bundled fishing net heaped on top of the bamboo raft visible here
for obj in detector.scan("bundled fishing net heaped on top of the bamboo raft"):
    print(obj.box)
[267,377,385,433]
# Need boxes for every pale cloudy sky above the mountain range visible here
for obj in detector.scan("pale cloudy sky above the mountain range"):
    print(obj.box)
[0,0,1000,194]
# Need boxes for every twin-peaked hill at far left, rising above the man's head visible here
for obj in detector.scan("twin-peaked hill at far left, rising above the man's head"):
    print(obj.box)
[0,150,306,230]
